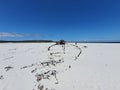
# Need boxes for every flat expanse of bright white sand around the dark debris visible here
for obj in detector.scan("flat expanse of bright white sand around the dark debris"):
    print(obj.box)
[0,43,120,90]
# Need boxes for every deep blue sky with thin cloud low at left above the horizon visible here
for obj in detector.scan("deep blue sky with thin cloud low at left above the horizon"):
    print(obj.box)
[0,0,120,40]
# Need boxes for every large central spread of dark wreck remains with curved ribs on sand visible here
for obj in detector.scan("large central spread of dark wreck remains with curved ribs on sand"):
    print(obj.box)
[21,40,82,90]
